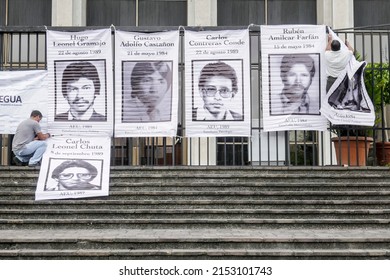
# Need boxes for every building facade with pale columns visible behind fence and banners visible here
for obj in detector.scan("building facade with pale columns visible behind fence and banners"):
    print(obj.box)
[0,0,390,165]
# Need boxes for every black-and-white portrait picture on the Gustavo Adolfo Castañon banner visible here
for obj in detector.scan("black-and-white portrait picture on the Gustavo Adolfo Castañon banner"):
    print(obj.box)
[122,61,173,123]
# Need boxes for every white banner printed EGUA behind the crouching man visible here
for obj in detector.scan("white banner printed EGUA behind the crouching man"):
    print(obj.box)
[0,70,47,134]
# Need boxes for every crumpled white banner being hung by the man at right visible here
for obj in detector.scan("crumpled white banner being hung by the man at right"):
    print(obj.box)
[321,29,375,126]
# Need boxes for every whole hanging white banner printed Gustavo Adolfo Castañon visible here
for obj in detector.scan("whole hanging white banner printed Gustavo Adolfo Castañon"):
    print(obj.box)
[115,30,179,137]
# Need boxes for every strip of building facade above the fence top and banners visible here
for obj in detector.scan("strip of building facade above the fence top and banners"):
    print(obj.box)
[0,0,390,29]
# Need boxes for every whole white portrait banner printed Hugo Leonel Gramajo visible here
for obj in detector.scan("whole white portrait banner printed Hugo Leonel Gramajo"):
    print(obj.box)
[47,28,113,136]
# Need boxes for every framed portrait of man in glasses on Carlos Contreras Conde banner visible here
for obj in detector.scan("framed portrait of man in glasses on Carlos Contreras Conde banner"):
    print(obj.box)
[192,59,244,121]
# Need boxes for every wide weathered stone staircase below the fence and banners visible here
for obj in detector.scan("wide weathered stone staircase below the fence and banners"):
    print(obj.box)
[0,166,390,259]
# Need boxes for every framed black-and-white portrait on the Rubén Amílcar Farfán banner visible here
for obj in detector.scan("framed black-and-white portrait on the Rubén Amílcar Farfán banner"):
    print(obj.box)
[269,54,321,115]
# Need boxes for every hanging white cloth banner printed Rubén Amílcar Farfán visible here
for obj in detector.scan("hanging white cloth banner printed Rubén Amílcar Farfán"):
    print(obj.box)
[261,25,327,131]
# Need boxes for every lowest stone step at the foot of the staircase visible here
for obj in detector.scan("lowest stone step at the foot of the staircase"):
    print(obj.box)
[0,249,390,260]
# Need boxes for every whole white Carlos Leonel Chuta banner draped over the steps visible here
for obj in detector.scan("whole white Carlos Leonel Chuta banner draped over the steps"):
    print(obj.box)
[35,136,111,200]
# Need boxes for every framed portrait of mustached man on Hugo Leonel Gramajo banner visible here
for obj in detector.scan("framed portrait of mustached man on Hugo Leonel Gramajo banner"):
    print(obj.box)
[54,60,107,122]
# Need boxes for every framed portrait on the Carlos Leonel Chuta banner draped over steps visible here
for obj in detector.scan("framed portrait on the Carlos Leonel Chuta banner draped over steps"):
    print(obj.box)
[44,158,103,191]
